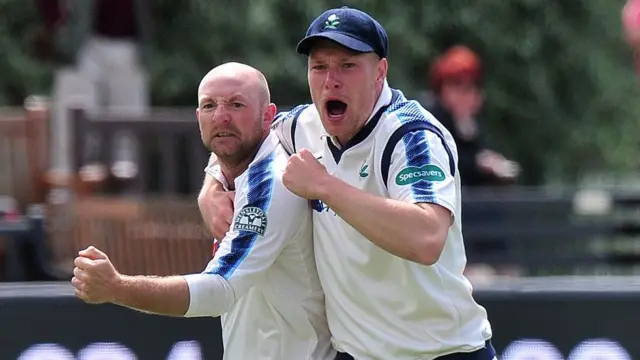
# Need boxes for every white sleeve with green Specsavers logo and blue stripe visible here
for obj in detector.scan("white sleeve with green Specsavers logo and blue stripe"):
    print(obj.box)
[387,124,457,214]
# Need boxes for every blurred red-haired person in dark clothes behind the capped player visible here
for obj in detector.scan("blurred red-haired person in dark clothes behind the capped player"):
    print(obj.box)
[425,46,519,186]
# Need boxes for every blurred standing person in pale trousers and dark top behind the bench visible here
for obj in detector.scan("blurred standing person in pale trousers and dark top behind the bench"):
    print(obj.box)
[35,0,151,188]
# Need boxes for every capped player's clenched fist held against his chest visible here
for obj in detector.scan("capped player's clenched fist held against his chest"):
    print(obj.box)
[282,149,331,200]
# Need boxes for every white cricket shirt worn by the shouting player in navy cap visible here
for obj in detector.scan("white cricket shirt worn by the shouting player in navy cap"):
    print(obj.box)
[274,82,491,360]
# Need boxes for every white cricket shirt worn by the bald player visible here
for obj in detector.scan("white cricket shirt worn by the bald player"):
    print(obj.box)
[185,133,336,360]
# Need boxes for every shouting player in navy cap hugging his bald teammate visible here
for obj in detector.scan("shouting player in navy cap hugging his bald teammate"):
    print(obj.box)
[198,7,496,360]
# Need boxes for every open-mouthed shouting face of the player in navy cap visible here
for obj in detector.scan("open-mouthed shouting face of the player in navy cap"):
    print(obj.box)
[308,40,387,145]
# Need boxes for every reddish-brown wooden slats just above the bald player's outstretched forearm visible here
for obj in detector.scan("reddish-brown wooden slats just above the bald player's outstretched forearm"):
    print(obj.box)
[47,196,213,275]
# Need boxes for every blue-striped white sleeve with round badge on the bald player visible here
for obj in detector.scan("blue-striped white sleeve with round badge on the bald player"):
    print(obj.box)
[204,155,308,299]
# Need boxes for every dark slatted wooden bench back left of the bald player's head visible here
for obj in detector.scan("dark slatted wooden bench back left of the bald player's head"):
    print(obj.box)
[73,108,208,195]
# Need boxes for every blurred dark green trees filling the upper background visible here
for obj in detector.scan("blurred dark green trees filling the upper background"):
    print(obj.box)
[0,0,640,184]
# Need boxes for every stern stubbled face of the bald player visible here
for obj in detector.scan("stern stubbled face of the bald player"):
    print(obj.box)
[196,74,275,164]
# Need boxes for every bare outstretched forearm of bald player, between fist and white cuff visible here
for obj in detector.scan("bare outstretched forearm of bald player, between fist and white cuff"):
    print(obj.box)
[113,275,190,316]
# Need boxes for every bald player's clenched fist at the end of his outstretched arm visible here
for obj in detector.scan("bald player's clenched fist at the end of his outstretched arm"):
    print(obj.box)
[71,246,120,304]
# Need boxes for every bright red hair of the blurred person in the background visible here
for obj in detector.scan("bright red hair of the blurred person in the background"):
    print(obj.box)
[429,45,482,93]
